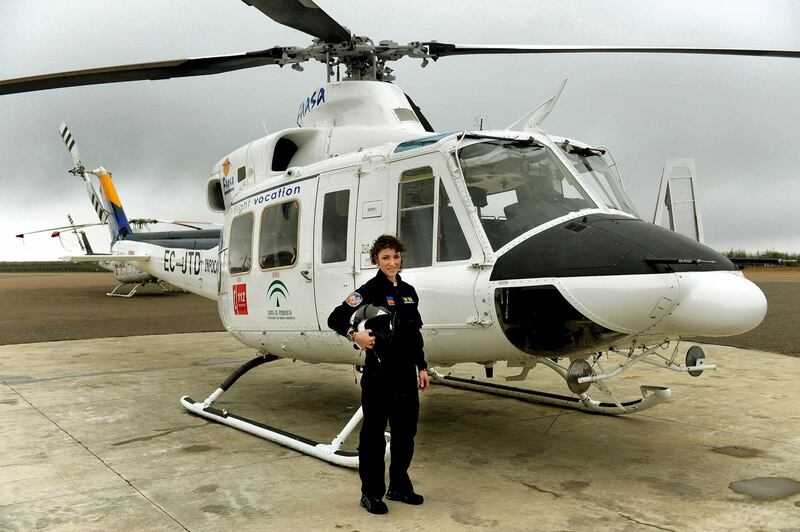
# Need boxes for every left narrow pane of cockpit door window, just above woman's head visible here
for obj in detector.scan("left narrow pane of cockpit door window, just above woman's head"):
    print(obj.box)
[397,166,435,268]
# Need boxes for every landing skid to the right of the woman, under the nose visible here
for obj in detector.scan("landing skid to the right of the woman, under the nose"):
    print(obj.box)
[430,363,672,415]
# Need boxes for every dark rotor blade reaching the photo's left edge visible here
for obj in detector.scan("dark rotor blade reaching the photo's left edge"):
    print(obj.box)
[0,46,285,94]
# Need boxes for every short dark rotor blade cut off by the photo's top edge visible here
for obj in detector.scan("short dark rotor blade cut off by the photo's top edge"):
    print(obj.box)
[242,0,350,44]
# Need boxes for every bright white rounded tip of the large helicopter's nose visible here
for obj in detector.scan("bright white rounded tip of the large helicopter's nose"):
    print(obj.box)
[657,272,767,336]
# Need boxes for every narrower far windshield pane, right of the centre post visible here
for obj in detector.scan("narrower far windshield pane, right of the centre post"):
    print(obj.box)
[560,143,639,218]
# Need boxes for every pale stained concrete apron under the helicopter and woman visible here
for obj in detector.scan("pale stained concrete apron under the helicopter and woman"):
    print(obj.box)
[0,333,800,530]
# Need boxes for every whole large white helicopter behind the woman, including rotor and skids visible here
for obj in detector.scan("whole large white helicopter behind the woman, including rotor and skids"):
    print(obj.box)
[0,0,800,467]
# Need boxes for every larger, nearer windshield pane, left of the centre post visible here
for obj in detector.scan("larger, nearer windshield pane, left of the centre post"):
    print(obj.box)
[458,140,597,250]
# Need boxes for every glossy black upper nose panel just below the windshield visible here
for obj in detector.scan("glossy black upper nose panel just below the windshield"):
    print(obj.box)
[491,214,737,281]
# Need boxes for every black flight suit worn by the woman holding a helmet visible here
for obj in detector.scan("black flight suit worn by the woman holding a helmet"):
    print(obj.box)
[328,270,428,499]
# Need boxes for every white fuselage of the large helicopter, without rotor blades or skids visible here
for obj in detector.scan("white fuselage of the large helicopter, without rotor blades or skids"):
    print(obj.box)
[109,82,766,365]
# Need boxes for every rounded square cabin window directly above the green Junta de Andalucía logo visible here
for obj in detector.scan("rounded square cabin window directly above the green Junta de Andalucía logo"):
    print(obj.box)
[258,201,300,270]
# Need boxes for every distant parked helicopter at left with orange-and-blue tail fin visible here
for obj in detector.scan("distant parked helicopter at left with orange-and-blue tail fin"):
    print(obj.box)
[17,122,220,298]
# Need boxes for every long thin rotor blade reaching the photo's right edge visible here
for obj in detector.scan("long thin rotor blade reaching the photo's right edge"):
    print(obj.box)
[423,42,800,59]
